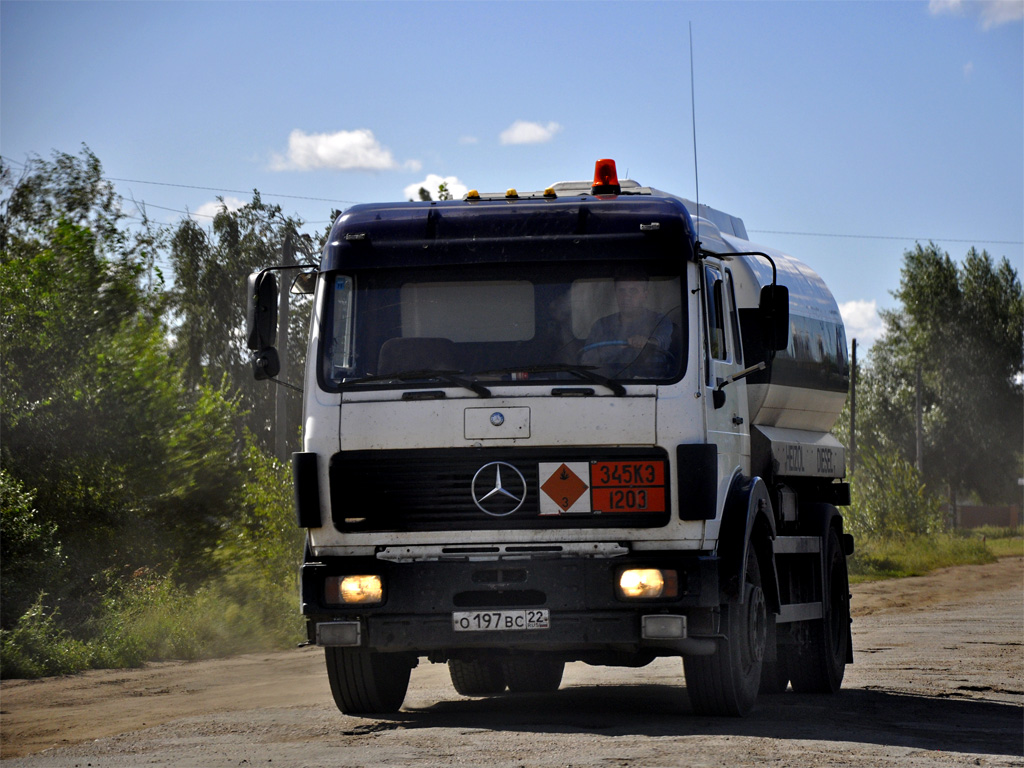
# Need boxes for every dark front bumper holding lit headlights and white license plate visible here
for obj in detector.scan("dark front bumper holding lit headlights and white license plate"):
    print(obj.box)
[301,552,719,655]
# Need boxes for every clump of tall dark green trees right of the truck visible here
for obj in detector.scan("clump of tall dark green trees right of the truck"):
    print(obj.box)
[857,244,1024,512]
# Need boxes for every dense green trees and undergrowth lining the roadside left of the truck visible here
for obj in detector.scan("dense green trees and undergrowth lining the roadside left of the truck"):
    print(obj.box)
[0,147,314,676]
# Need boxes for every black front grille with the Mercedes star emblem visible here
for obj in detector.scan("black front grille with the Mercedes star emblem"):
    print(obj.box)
[330,447,671,531]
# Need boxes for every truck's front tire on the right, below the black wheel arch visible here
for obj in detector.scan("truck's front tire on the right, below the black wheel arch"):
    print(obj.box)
[683,546,768,717]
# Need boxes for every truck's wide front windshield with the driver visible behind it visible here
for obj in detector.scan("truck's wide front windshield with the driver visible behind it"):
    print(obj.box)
[321,262,686,392]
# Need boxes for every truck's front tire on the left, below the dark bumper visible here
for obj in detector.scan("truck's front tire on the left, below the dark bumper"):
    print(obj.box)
[325,646,413,715]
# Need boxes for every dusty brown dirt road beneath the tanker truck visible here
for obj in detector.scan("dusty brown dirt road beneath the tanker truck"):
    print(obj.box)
[0,558,1024,768]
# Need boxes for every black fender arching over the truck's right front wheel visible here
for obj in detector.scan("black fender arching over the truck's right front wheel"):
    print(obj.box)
[718,475,781,613]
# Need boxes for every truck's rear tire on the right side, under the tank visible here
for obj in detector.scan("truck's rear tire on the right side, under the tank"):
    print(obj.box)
[788,527,850,693]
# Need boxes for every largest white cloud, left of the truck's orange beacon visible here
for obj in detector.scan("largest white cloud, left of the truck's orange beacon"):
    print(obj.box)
[270,128,422,171]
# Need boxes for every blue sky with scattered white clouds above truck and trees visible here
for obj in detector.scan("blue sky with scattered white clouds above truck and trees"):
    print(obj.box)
[0,0,1024,349]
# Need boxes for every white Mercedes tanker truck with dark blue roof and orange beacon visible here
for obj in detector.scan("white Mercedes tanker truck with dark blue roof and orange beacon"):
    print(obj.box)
[248,161,853,716]
